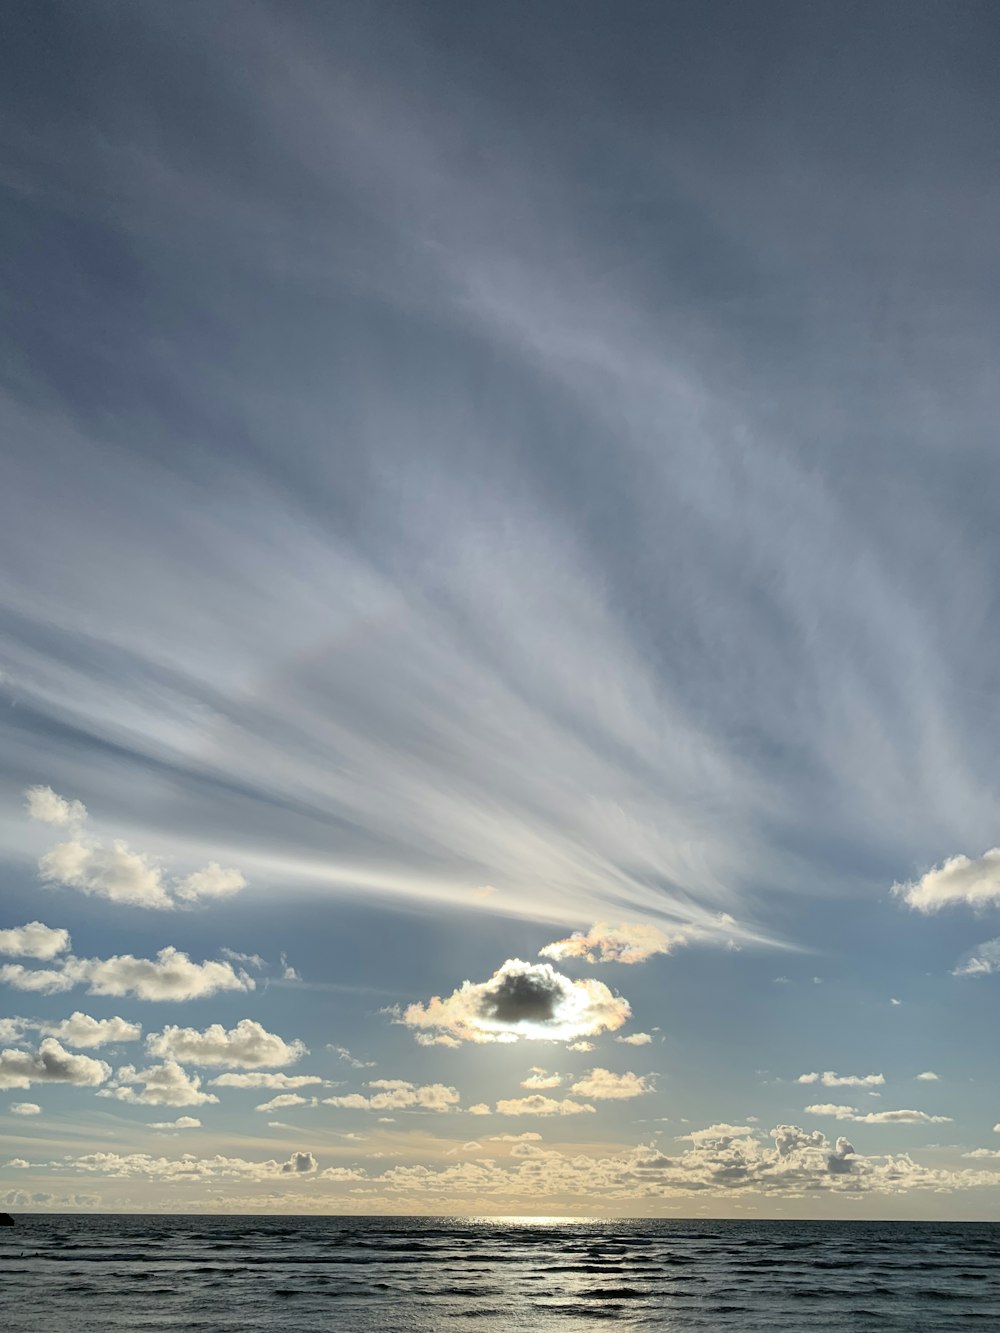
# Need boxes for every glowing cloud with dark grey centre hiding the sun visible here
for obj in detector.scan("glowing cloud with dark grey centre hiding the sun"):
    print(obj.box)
[400,958,632,1042]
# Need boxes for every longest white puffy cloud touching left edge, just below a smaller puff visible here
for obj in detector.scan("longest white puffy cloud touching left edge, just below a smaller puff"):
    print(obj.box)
[0,946,255,1001]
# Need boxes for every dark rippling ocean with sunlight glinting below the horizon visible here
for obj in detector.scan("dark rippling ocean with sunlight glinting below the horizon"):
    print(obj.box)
[0,1214,1000,1333]
